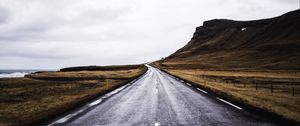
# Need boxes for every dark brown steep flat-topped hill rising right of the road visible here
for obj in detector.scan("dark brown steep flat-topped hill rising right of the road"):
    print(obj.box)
[158,10,300,71]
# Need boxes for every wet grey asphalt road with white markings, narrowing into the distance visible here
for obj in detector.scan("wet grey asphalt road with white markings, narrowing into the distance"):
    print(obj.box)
[49,66,275,126]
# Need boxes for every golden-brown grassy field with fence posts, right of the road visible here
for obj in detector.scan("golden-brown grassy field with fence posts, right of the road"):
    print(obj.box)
[155,62,300,122]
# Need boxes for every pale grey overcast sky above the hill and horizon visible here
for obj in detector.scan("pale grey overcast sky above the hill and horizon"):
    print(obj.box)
[0,0,299,69]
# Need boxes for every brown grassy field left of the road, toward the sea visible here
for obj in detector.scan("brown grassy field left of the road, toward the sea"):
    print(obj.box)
[0,65,147,126]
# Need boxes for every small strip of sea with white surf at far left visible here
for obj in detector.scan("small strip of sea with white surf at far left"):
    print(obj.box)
[0,70,41,78]
